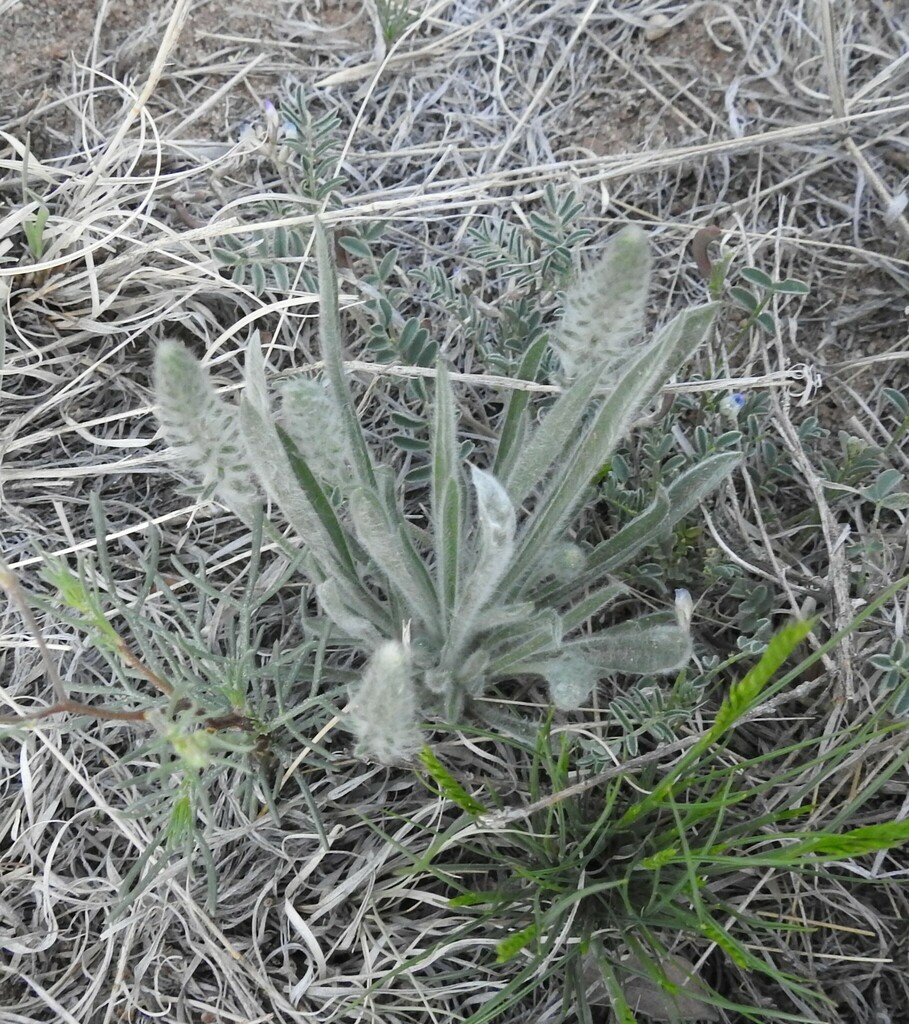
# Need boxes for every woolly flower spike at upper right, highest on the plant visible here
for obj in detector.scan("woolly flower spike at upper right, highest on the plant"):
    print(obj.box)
[553,224,650,380]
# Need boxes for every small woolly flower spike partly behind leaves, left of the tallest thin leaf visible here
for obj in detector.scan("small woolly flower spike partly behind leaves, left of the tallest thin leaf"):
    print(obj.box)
[279,377,350,487]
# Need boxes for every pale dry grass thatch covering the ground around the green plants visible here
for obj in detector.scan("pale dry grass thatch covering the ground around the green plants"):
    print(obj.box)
[0,0,909,1024]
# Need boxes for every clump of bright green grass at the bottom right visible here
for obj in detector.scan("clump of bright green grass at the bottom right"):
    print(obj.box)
[373,598,909,1024]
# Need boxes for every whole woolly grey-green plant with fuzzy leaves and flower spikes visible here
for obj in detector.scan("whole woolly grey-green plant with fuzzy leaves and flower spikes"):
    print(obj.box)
[156,227,738,761]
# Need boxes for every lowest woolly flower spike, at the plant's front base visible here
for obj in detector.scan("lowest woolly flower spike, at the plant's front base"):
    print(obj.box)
[348,640,423,764]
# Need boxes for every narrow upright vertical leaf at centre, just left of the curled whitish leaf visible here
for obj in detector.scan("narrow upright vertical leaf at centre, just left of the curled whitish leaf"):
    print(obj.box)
[431,362,463,630]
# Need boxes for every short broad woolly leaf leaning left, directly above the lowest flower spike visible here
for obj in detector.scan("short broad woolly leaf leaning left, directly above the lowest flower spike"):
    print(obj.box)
[350,487,438,631]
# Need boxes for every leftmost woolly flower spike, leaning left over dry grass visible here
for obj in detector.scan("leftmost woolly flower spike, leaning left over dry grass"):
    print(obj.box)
[155,339,260,522]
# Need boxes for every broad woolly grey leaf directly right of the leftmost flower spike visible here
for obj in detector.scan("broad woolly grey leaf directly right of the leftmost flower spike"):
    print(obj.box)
[240,396,356,582]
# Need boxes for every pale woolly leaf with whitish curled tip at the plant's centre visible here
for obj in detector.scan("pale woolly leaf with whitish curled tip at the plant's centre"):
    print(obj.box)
[444,466,517,669]
